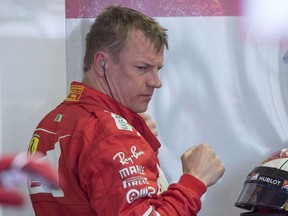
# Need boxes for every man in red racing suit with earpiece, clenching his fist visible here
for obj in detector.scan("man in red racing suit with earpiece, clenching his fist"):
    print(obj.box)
[29,6,224,216]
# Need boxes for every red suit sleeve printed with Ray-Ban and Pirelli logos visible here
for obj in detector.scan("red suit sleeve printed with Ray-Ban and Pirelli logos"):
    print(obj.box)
[79,132,206,216]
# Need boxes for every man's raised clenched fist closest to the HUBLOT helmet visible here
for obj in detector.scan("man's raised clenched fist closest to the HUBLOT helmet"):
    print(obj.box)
[181,144,225,187]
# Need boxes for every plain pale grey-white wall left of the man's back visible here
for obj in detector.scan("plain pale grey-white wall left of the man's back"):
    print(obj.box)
[0,0,66,216]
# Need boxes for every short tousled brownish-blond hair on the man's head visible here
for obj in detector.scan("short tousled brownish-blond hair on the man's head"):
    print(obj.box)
[83,5,168,72]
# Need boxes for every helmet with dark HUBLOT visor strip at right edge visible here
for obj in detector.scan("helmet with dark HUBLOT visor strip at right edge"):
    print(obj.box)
[235,148,288,215]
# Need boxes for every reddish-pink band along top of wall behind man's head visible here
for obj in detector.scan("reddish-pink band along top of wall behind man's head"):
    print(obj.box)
[66,0,241,18]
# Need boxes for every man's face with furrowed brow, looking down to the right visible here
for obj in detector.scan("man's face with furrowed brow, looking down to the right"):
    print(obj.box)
[111,31,164,113]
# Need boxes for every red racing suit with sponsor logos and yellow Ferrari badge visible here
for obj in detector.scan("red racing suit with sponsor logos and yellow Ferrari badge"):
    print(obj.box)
[28,82,207,216]
